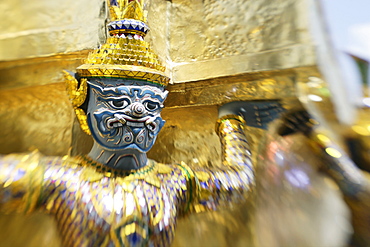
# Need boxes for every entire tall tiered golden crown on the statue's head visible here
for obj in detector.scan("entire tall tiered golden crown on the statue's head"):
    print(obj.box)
[77,0,170,87]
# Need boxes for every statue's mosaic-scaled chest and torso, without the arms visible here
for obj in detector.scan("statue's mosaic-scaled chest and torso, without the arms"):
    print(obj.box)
[45,159,187,246]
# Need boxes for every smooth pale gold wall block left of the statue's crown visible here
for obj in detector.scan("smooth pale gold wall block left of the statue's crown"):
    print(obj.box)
[0,0,106,61]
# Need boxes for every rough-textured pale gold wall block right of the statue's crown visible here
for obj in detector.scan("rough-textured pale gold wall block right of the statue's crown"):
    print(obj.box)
[169,0,315,82]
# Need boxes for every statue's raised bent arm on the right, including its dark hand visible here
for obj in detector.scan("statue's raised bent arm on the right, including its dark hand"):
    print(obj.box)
[183,100,285,212]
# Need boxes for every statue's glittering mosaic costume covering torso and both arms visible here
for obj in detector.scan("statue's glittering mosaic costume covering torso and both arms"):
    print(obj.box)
[0,116,254,246]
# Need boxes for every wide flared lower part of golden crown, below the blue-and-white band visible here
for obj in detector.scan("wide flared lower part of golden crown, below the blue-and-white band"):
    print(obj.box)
[77,37,170,86]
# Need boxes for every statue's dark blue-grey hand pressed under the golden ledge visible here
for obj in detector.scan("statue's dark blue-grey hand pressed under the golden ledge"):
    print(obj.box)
[218,100,285,129]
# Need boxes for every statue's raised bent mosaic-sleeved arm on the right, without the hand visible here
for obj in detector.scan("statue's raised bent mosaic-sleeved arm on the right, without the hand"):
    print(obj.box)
[184,104,255,212]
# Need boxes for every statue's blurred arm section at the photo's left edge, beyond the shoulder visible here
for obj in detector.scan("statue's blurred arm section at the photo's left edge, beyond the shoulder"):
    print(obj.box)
[0,152,44,212]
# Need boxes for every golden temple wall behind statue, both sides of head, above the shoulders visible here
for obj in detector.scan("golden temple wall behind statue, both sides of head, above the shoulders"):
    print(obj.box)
[0,0,317,163]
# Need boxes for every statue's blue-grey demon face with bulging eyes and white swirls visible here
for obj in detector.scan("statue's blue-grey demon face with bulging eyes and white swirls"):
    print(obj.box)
[87,79,168,153]
